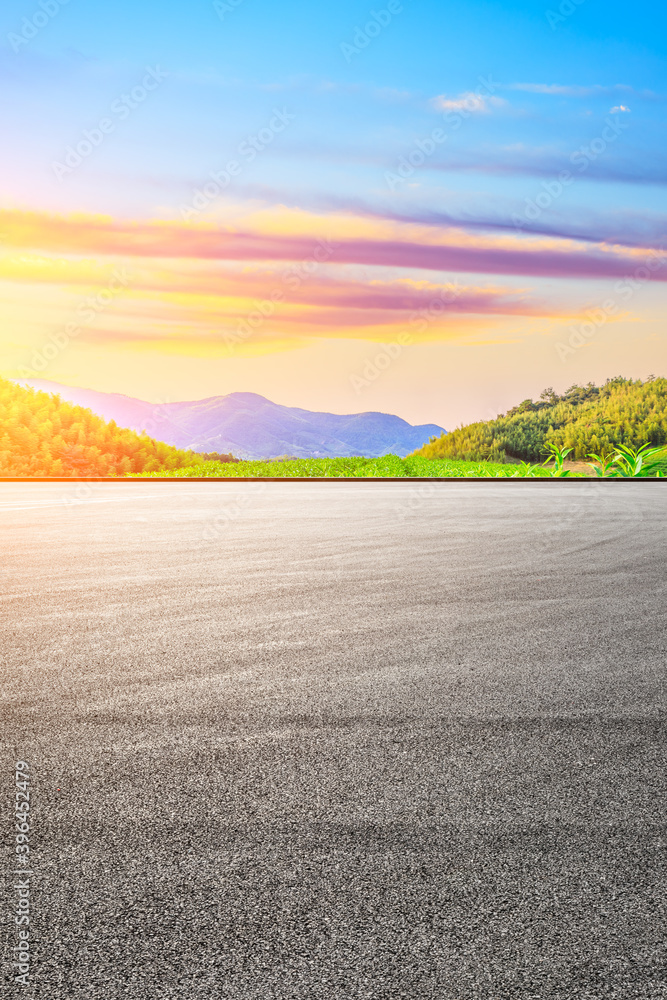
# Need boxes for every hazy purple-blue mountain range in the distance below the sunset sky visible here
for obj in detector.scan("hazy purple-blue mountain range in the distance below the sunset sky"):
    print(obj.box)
[15,379,444,458]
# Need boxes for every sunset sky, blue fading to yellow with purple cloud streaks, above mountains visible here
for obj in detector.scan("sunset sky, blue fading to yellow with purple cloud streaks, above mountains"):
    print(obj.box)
[0,2,667,424]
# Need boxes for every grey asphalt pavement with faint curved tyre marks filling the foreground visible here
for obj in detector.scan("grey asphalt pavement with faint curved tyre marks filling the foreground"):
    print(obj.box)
[0,481,667,1000]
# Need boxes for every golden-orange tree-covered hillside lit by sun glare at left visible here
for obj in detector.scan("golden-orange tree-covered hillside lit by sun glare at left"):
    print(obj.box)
[0,379,203,477]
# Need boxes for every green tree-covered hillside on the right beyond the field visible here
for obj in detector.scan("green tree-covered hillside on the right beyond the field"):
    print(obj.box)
[414,376,667,462]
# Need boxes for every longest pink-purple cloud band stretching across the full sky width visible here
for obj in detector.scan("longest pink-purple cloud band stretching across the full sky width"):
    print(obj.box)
[5,211,667,281]
